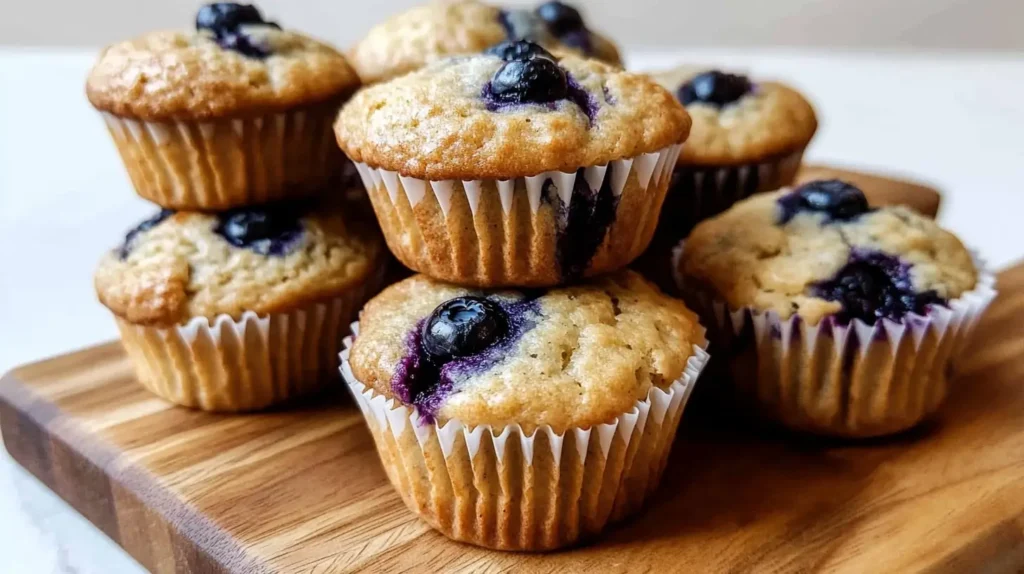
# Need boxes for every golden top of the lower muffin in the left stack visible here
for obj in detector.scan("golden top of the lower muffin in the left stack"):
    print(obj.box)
[95,198,384,325]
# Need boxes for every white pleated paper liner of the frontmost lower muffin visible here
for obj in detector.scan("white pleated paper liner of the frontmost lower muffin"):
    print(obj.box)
[341,322,708,550]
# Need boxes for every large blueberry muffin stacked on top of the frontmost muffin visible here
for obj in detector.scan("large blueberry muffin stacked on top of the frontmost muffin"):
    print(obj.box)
[335,42,689,286]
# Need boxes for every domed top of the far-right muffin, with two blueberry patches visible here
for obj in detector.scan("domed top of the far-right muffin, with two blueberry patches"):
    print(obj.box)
[677,180,978,324]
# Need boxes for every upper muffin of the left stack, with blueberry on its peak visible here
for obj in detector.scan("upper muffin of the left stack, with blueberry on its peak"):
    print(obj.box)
[86,3,358,211]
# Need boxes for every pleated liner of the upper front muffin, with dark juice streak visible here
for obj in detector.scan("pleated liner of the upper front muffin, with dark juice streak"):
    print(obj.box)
[356,145,681,286]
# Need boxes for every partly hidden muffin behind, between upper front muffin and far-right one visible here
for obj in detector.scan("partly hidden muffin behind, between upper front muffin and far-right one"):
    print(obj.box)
[653,68,817,243]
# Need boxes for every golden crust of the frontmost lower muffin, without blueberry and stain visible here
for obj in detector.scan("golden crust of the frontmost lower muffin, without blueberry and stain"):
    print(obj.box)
[350,271,703,431]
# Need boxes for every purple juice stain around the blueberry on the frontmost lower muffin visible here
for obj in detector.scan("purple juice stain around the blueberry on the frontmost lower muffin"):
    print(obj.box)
[391,294,541,425]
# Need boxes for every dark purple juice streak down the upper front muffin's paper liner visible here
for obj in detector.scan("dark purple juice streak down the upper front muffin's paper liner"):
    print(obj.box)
[543,163,618,281]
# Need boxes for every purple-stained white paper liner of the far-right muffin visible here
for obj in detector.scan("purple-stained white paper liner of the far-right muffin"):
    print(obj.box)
[673,244,996,438]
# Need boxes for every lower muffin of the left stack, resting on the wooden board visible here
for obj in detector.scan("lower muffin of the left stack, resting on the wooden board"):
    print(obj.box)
[95,203,386,411]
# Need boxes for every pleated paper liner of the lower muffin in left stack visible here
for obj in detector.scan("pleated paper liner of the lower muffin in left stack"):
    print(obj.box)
[117,274,381,411]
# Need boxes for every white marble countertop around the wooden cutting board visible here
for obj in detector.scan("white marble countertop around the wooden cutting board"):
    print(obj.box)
[0,49,1024,574]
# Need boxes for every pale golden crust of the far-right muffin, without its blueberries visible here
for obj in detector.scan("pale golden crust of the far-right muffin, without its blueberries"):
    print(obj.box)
[678,189,978,324]
